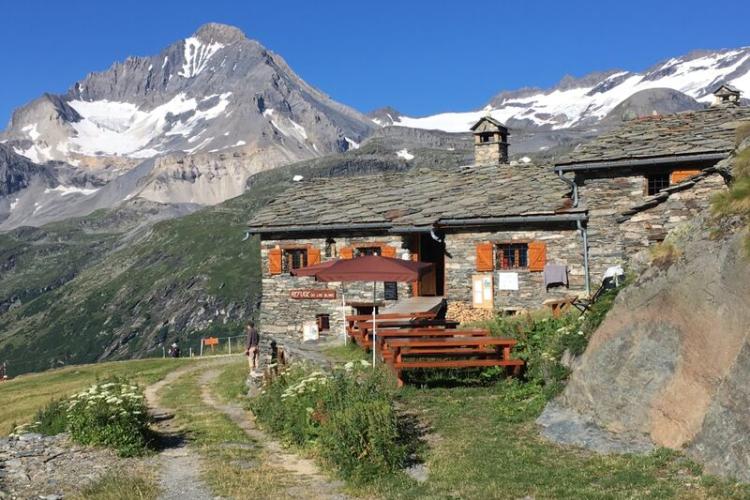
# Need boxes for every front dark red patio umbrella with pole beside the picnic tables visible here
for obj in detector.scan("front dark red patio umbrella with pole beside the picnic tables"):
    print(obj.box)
[308,255,432,367]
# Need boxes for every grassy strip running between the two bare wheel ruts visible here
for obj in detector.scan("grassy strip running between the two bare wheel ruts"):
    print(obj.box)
[161,360,289,498]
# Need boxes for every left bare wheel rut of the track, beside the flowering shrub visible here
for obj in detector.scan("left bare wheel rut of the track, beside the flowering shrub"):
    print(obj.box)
[144,363,215,500]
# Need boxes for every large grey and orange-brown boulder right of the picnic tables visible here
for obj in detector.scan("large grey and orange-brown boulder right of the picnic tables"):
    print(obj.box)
[538,223,750,481]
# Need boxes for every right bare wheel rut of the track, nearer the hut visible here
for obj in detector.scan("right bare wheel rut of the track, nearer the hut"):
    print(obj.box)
[200,367,348,499]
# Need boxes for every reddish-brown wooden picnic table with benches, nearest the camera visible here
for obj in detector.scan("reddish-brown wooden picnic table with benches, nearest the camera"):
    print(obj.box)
[386,336,524,387]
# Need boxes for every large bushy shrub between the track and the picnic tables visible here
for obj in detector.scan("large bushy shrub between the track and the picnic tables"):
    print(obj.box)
[251,361,408,482]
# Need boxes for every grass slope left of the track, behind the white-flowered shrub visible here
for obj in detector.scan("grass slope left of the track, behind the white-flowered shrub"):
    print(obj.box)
[0,359,191,435]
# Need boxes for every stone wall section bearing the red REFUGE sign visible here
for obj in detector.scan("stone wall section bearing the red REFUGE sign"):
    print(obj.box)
[259,235,411,338]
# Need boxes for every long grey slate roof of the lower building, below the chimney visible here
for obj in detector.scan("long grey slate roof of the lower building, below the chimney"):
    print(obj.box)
[249,165,583,229]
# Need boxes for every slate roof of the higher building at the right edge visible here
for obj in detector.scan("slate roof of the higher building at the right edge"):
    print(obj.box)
[556,106,750,169]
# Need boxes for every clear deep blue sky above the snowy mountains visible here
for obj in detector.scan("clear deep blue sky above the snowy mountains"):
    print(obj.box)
[0,0,750,127]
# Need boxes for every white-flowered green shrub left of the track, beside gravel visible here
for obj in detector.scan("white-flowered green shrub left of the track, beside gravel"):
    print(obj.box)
[67,379,151,457]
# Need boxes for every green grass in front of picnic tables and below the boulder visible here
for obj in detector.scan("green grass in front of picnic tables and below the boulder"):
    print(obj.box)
[356,381,750,499]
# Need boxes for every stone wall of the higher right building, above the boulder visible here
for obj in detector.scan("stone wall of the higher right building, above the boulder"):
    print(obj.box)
[576,173,726,290]
